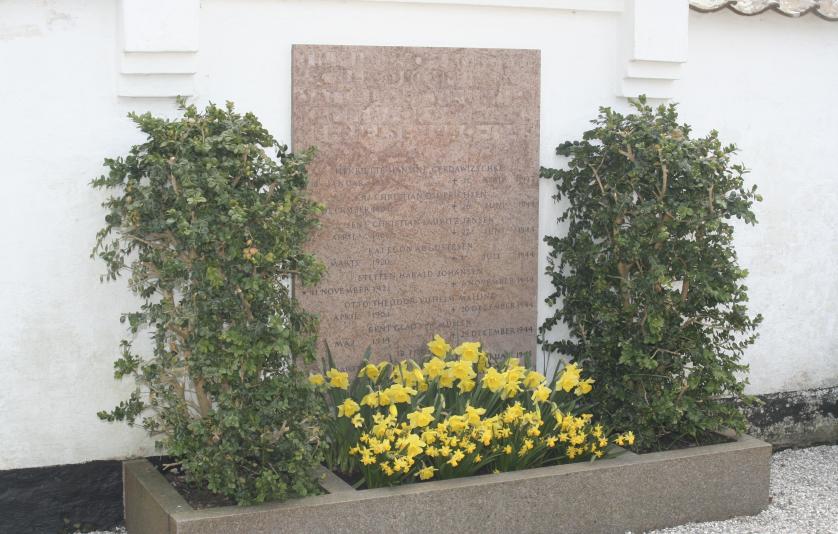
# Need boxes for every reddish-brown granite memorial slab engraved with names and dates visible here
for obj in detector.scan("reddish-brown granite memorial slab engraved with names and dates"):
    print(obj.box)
[293,45,540,367]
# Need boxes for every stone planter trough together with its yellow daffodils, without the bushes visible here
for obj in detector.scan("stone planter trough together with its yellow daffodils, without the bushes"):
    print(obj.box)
[124,336,771,534]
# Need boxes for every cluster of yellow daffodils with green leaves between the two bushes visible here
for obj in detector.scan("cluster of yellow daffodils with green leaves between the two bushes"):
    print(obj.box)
[309,335,634,488]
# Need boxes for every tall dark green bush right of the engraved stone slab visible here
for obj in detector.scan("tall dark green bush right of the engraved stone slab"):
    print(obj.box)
[540,97,762,448]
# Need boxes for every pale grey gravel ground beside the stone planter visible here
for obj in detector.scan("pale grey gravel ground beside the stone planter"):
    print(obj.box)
[80,445,838,534]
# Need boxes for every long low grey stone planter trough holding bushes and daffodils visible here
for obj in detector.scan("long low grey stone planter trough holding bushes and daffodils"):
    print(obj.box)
[123,436,771,534]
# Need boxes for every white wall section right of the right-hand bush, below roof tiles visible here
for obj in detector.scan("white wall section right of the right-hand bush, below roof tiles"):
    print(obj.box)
[675,12,838,393]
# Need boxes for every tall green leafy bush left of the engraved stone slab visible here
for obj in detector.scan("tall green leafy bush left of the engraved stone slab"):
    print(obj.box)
[93,102,324,504]
